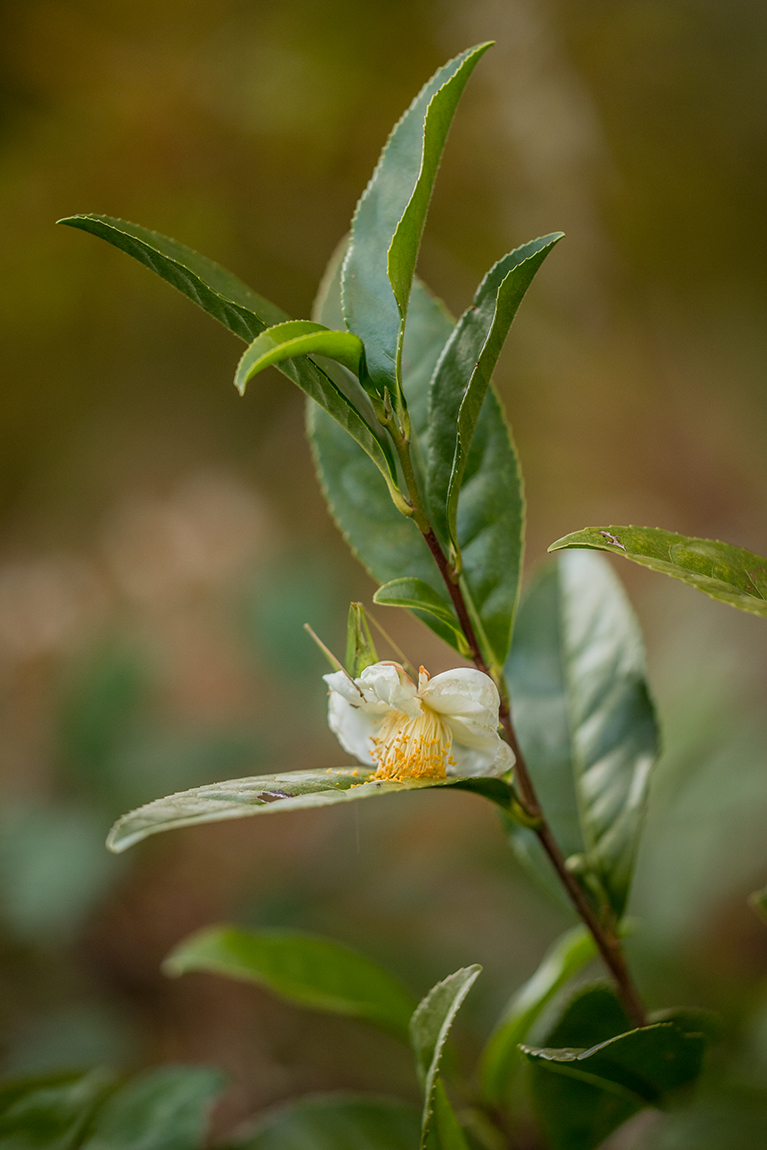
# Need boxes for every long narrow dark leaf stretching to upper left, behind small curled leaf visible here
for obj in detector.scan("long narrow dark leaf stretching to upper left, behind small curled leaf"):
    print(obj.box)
[59,215,398,499]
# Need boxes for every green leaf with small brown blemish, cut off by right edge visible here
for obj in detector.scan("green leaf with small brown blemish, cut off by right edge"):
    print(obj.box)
[549,526,767,618]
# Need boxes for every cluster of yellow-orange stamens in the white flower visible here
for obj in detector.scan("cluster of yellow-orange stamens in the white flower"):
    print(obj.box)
[370,704,455,782]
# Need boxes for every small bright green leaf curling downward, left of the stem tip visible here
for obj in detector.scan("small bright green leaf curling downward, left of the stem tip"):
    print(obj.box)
[235,320,365,396]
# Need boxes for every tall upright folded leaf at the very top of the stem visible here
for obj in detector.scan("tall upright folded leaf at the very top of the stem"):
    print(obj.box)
[343,44,490,399]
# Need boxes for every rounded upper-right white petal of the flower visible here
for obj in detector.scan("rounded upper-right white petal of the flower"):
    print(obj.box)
[421,667,500,750]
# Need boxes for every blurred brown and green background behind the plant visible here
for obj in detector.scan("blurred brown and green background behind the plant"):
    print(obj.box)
[0,0,767,1145]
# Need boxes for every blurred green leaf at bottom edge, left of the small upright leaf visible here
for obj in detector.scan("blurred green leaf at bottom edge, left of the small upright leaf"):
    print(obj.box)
[232,1094,421,1150]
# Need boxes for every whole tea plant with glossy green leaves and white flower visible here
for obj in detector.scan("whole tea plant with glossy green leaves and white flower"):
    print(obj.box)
[8,44,767,1150]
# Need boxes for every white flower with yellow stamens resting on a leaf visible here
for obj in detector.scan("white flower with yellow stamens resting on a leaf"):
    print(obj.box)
[323,662,514,782]
